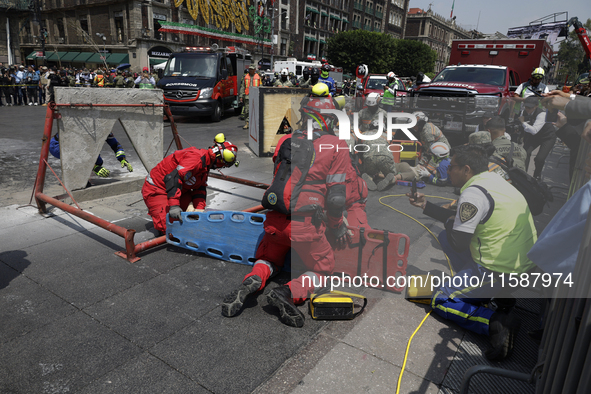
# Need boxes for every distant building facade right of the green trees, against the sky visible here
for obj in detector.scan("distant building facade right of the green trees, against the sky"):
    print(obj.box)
[404,8,473,73]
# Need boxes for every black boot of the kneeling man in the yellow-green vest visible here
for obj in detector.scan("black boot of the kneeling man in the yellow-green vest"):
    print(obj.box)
[484,313,521,361]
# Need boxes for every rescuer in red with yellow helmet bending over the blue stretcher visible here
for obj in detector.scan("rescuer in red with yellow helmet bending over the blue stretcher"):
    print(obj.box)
[142,133,239,233]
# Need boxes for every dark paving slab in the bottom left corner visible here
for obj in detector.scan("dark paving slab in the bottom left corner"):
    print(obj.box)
[0,312,141,393]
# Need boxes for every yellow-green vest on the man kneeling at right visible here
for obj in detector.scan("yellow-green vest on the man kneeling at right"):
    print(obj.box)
[462,172,537,273]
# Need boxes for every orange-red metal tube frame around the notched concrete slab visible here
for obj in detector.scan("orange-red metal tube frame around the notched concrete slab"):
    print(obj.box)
[34,102,268,263]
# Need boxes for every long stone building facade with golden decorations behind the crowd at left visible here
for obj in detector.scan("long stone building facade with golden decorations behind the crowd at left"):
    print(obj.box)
[9,0,409,71]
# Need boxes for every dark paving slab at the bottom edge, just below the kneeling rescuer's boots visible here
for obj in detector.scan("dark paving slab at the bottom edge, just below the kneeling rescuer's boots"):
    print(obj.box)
[150,284,326,393]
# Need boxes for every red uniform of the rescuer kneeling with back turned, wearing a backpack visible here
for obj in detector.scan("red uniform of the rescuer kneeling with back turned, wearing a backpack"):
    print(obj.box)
[244,134,350,304]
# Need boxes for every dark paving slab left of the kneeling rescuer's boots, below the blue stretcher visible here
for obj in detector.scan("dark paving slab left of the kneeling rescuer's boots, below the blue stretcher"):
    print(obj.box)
[85,258,247,349]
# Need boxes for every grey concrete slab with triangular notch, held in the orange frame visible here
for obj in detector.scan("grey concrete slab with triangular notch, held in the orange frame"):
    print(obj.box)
[55,87,163,190]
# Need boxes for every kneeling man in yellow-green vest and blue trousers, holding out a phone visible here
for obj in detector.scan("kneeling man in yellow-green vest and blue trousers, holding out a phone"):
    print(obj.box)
[407,145,537,361]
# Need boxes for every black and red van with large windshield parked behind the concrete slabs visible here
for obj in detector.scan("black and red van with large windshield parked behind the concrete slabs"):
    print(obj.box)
[157,47,251,122]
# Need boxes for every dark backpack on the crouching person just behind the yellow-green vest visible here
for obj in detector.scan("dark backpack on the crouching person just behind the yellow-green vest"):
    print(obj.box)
[491,142,554,216]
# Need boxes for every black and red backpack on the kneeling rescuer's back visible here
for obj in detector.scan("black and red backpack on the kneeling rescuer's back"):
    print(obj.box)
[261,131,316,215]
